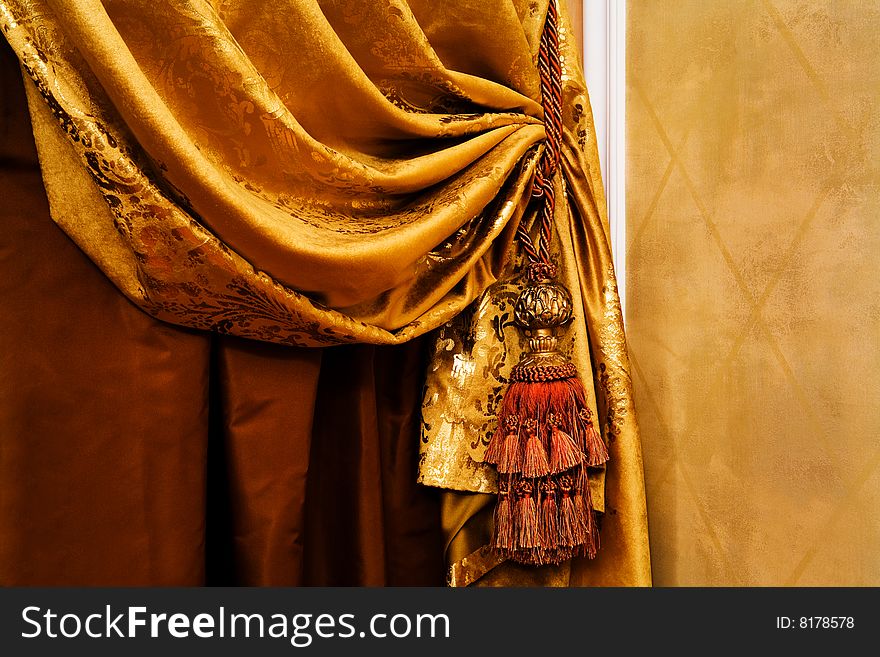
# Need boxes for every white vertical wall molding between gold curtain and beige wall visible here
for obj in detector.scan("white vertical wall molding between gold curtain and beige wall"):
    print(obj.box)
[584,0,626,318]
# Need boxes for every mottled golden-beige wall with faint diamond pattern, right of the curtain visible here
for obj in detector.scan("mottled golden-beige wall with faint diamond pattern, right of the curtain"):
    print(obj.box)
[626,0,880,586]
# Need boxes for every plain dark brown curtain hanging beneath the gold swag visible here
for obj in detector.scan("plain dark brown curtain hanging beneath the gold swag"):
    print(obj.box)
[0,39,444,586]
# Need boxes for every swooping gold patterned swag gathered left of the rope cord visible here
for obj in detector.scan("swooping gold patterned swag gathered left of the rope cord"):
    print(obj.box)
[0,0,544,346]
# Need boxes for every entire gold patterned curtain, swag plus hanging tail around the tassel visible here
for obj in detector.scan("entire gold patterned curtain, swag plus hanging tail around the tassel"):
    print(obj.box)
[0,0,650,584]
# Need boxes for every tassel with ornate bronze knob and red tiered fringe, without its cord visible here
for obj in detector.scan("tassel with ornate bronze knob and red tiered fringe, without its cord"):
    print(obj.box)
[485,281,608,564]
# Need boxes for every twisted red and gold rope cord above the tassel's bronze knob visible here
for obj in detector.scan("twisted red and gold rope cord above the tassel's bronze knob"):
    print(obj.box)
[517,0,562,279]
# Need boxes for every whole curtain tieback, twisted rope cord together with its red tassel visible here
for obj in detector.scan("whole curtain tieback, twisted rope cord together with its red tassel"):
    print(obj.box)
[485,0,608,565]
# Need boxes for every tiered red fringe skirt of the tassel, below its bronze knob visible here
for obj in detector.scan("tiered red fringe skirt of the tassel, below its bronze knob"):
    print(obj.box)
[485,377,608,564]
